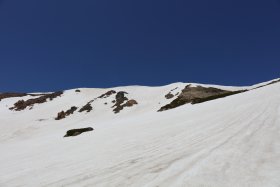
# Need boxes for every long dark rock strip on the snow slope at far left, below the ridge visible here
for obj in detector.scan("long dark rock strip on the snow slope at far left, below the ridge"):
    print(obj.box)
[10,91,63,111]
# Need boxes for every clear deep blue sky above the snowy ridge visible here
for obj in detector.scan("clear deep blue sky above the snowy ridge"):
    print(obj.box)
[0,0,280,92]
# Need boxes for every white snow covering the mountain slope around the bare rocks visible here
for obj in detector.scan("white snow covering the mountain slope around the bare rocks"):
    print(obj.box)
[0,79,280,187]
